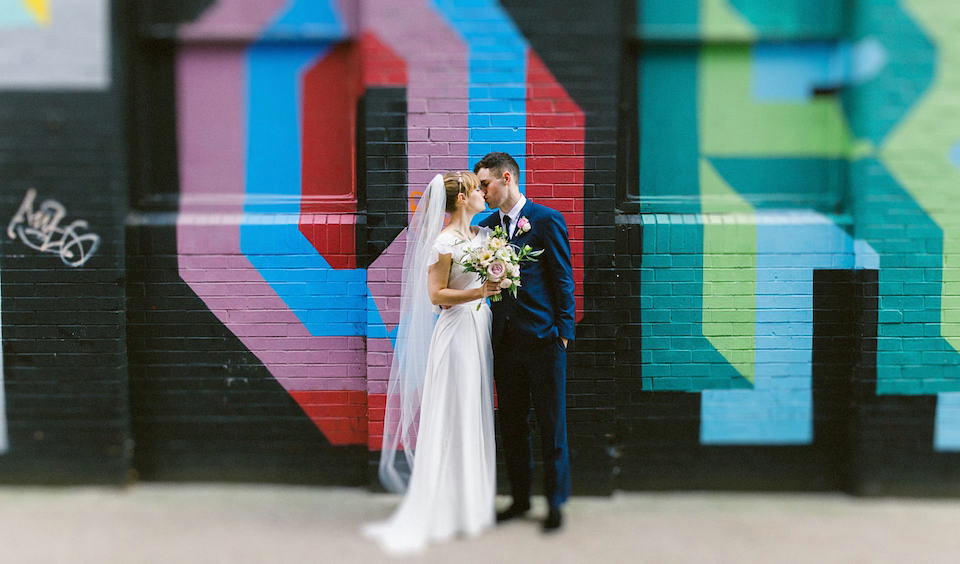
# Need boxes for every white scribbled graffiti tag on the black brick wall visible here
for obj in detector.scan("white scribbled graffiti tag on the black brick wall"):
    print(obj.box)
[7,188,100,267]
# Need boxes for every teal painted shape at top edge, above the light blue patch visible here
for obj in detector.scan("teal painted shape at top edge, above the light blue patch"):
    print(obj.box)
[730,0,849,39]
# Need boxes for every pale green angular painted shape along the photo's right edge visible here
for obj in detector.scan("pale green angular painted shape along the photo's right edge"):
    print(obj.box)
[880,0,960,351]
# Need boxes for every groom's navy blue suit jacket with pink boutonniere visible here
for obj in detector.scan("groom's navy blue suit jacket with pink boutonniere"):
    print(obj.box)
[480,203,574,342]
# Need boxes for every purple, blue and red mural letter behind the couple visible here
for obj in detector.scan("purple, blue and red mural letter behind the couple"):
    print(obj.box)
[177,1,584,448]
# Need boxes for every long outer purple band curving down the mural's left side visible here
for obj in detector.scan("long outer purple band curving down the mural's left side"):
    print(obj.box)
[177,0,366,390]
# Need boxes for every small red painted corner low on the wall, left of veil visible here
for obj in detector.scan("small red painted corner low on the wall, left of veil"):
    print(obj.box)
[290,390,368,446]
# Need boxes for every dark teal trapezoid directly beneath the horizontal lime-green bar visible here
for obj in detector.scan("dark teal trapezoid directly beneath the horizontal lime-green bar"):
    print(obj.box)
[710,157,849,214]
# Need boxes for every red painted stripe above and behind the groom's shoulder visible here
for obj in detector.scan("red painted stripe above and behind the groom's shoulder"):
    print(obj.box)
[526,51,585,321]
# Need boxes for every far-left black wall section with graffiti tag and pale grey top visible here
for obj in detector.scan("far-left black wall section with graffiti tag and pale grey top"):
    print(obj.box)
[0,1,131,483]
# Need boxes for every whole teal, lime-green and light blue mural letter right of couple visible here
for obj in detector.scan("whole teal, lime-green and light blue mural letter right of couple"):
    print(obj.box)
[638,0,960,458]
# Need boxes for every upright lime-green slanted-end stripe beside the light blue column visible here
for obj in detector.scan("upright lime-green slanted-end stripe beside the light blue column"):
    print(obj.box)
[700,159,757,384]
